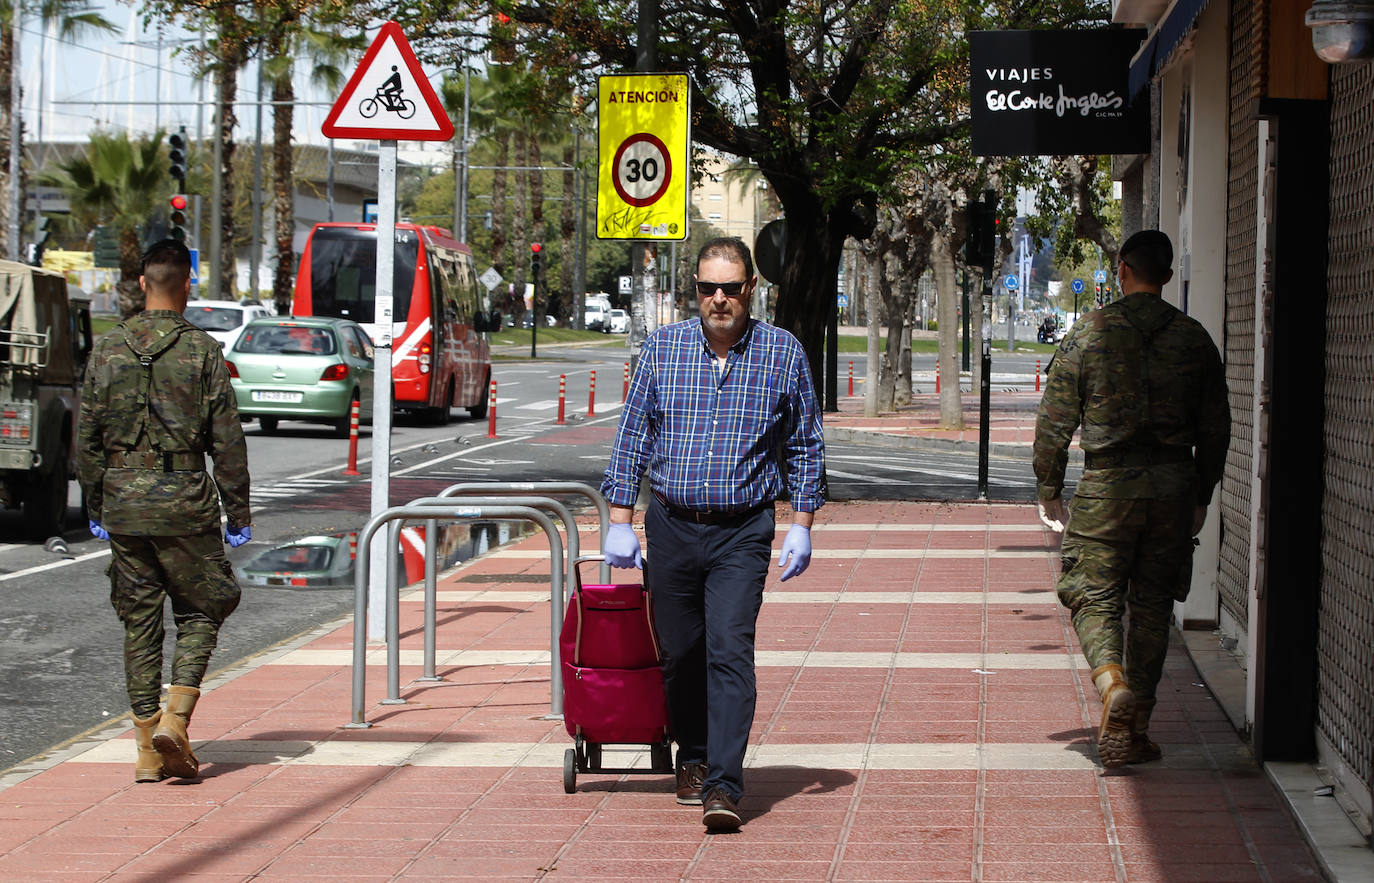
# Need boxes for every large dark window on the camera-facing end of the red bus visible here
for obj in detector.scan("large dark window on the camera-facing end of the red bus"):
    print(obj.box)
[311,227,419,324]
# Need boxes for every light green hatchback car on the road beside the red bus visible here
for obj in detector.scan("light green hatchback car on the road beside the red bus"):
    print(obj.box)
[225,316,372,438]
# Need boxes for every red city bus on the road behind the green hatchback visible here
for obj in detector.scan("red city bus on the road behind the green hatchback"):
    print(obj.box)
[291,224,500,423]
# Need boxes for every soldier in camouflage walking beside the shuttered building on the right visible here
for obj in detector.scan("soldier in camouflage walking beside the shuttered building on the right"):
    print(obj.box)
[1035,229,1231,768]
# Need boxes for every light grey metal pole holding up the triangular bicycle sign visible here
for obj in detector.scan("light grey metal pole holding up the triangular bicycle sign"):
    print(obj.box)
[367,140,396,641]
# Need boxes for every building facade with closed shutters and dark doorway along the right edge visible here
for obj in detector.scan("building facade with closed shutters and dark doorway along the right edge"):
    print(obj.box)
[1113,0,1374,838]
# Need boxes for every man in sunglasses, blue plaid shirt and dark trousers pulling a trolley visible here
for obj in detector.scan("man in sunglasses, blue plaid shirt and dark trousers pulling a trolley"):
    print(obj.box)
[602,239,824,831]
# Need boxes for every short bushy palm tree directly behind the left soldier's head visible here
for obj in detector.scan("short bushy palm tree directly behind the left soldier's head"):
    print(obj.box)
[37,130,166,316]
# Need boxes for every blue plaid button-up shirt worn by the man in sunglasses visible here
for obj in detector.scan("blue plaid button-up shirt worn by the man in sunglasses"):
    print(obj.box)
[602,319,826,512]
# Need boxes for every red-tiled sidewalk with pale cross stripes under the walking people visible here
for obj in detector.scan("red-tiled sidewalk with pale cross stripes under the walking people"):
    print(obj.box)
[0,503,1341,883]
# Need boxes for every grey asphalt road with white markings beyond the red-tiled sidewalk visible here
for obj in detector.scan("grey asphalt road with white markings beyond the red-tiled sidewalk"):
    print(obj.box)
[0,346,1060,769]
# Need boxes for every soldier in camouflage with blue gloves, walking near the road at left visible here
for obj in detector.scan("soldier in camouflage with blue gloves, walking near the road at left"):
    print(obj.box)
[77,239,253,781]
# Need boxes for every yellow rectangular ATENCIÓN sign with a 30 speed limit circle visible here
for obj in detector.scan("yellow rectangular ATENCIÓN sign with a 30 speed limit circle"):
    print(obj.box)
[596,74,691,239]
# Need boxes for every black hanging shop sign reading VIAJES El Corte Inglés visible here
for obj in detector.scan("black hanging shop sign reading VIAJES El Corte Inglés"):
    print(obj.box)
[969,29,1150,157]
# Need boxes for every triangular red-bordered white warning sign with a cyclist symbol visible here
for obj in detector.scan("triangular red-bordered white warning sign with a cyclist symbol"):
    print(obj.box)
[320,22,453,141]
